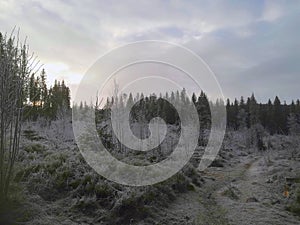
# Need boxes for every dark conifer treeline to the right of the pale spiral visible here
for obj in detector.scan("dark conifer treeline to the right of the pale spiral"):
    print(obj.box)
[226,94,300,134]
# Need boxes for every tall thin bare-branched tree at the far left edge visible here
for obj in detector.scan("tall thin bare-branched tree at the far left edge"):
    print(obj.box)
[0,30,31,200]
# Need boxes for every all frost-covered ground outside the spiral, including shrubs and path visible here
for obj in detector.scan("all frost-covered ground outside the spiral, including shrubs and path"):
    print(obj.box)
[0,121,300,225]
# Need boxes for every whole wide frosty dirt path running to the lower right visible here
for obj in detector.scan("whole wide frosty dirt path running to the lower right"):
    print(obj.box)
[152,155,300,225]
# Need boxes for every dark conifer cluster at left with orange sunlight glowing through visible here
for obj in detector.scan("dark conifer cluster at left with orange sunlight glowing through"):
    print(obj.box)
[24,69,70,120]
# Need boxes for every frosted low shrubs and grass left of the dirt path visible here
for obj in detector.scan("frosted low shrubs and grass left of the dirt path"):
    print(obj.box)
[11,118,201,224]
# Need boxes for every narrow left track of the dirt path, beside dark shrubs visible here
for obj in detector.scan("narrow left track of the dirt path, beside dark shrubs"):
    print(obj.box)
[150,156,255,225]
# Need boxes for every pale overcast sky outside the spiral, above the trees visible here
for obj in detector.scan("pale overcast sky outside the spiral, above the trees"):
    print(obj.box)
[0,0,300,101]
